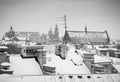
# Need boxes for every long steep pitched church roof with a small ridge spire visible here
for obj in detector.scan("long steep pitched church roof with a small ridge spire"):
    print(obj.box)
[63,31,109,44]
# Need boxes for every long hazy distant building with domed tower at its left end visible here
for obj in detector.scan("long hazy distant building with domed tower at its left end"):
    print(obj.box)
[2,27,40,44]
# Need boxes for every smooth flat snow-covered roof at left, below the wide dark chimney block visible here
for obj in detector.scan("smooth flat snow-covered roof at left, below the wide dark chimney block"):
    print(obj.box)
[10,55,43,75]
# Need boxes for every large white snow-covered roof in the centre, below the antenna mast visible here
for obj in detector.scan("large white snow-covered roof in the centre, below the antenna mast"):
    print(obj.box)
[46,52,90,74]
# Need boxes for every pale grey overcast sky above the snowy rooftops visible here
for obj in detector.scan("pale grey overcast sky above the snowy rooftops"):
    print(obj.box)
[0,0,120,39]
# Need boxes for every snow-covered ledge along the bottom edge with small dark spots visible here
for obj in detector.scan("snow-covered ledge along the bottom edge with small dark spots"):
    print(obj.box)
[0,74,120,82]
